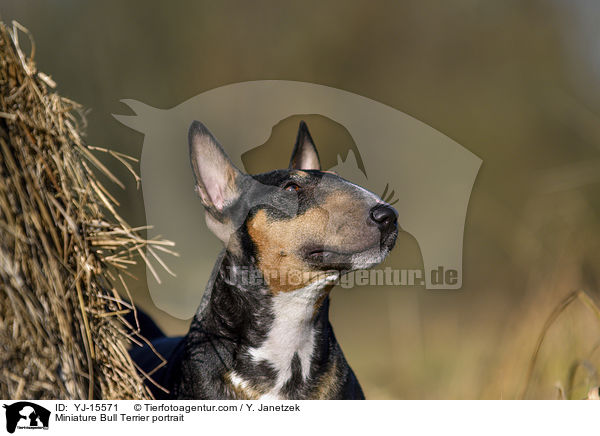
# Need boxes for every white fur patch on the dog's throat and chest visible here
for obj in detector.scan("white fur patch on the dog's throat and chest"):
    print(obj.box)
[231,278,331,399]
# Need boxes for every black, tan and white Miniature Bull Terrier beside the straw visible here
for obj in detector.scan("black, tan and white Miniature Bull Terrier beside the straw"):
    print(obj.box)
[130,121,398,400]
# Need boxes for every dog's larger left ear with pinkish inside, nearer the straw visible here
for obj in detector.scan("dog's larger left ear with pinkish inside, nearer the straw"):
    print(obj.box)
[188,121,243,215]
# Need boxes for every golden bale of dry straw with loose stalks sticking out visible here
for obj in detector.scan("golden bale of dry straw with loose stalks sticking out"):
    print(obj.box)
[0,22,172,399]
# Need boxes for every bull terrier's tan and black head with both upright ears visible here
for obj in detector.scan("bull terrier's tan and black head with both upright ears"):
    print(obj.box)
[188,121,398,293]
